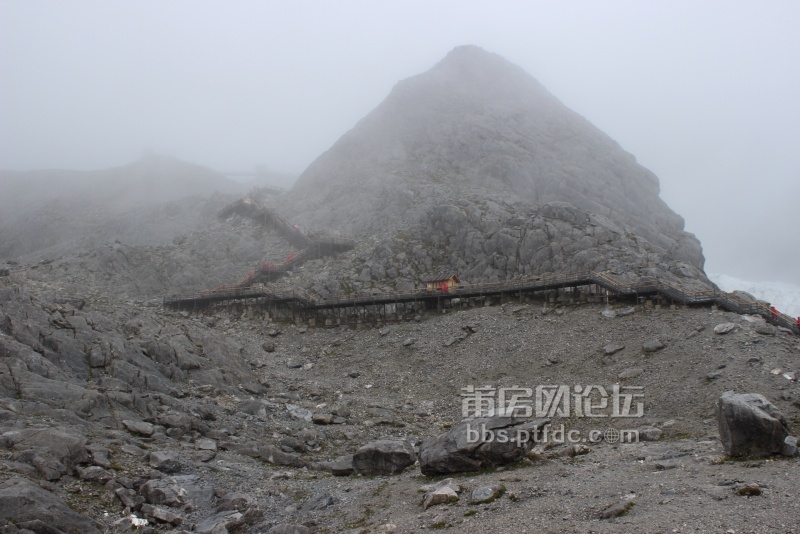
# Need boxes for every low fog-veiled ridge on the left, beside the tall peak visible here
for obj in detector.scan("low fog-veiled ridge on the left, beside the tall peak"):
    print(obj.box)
[0,156,246,260]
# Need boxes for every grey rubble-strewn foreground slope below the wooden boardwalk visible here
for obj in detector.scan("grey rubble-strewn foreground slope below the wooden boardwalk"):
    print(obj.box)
[0,271,800,532]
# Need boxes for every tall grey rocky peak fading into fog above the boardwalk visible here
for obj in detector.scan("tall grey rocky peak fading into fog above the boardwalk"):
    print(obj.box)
[282,46,704,294]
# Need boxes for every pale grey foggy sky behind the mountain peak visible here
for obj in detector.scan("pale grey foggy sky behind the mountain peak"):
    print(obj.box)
[0,0,800,283]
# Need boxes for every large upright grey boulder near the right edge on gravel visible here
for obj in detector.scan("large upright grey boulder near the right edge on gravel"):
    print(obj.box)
[716,391,789,456]
